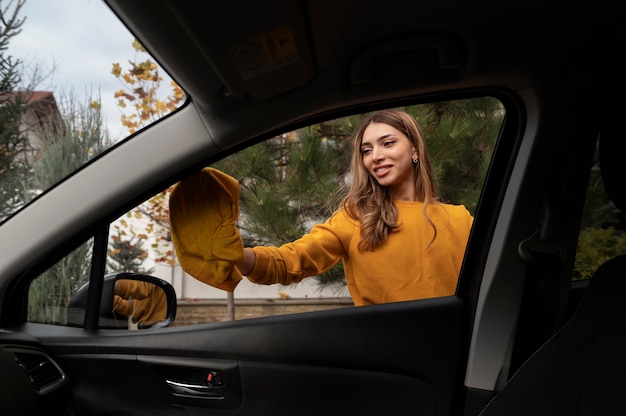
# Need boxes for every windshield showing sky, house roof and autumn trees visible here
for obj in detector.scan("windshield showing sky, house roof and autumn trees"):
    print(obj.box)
[0,0,184,222]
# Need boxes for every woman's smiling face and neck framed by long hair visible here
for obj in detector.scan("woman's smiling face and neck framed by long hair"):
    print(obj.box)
[361,123,418,201]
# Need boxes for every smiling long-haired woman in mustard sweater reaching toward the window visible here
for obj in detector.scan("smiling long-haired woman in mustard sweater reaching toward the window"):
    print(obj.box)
[237,110,473,306]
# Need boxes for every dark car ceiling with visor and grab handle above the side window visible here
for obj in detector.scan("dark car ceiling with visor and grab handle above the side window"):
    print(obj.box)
[107,0,621,147]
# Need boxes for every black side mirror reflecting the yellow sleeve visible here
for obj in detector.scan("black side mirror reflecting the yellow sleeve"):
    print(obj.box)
[67,273,176,329]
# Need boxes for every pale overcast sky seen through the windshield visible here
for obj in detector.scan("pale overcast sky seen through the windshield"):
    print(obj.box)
[8,0,145,139]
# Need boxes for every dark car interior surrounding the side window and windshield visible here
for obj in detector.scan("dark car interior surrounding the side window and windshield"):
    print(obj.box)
[0,0,626,416]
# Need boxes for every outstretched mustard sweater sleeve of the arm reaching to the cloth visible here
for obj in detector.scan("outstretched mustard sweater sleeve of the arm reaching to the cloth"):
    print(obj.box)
[246,211,356,285]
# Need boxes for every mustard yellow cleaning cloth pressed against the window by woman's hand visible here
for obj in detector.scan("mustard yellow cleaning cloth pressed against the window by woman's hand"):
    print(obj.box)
[169,168,243,292]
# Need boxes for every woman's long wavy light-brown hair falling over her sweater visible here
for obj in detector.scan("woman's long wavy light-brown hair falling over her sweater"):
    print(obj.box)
[341,110,439,251]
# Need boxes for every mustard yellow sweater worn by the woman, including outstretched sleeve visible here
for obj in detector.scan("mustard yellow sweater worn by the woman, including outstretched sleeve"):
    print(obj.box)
[246,201,473,306]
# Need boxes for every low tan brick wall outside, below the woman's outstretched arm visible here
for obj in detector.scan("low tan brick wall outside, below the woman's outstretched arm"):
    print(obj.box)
[171,298,353,326]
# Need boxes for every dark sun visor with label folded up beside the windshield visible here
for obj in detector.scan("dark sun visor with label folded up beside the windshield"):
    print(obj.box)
[170,0,314,99]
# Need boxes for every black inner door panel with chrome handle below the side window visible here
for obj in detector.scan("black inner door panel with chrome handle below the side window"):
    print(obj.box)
[28,297,468,415]
